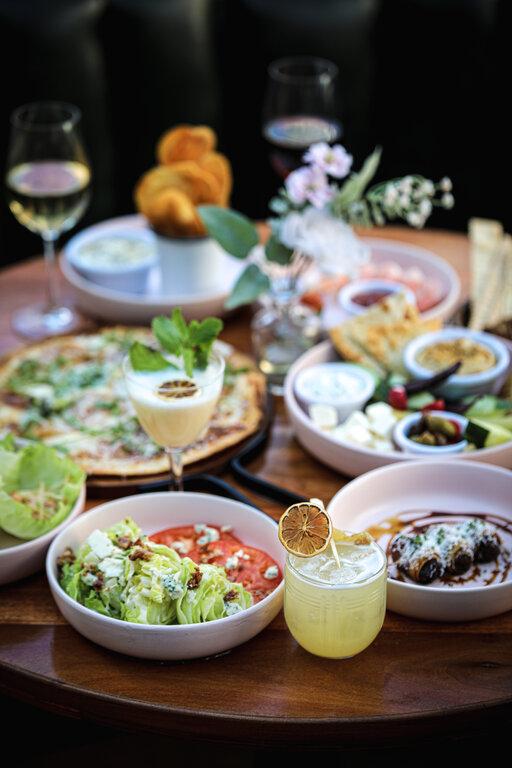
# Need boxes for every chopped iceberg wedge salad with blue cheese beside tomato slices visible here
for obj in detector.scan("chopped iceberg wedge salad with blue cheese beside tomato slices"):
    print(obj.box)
[57,518,280,625]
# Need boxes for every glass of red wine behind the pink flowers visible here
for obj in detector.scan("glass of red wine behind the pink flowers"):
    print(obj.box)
[263,56,342,180]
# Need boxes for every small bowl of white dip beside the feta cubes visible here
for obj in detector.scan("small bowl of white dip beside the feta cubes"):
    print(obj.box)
[294,362,375,422]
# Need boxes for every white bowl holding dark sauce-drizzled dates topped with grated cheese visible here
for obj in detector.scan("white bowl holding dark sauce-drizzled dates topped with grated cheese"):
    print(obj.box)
[328,459,512,621]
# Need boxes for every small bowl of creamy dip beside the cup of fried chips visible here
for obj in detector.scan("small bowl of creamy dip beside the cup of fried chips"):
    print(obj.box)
[64,231,158,293]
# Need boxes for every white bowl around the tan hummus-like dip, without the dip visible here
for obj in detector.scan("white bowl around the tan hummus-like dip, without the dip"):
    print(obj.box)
[403,328,510,400]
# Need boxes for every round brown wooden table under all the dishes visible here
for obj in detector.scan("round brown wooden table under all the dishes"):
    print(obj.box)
[0,228,512,747]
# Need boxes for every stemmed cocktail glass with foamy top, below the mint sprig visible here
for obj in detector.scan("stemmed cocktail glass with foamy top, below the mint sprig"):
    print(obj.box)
[123,352,225,491]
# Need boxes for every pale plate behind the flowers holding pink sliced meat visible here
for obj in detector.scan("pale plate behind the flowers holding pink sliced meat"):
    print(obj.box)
[322,237,460,328]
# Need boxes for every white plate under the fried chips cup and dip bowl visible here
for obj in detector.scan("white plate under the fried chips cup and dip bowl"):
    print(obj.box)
[60,215,245,323]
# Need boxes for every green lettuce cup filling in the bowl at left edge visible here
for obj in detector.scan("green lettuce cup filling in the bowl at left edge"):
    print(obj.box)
[0,435,85,541]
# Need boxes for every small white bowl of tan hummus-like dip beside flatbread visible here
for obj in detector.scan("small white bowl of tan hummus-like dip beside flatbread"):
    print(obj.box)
[403,328,510,400]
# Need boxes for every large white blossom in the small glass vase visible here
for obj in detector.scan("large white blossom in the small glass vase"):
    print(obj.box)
[279,207,369,277]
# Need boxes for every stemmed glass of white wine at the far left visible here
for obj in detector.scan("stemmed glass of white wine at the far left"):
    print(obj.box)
[5,101,91,338]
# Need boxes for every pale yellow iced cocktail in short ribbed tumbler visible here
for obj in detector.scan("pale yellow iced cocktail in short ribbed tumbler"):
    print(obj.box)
[284,541,387,659]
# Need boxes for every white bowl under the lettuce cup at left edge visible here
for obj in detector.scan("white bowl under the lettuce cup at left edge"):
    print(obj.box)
[0,484,85,584]
